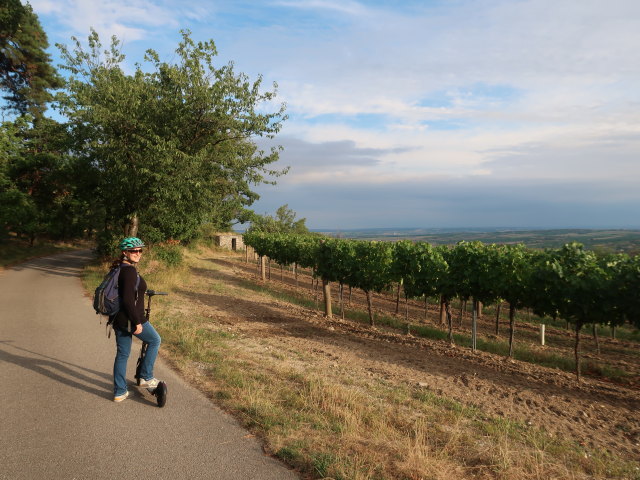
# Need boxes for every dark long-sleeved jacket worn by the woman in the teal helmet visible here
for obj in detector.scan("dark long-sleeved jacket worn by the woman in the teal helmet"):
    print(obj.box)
[113,262,147,332]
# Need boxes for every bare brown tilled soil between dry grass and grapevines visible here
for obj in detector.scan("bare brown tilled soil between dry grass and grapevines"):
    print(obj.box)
[188,253,640,461]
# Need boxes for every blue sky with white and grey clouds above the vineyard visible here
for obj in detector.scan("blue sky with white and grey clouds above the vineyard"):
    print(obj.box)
[31,0,640,230]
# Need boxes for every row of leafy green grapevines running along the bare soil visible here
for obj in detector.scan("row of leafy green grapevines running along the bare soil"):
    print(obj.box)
[244,232,640,378]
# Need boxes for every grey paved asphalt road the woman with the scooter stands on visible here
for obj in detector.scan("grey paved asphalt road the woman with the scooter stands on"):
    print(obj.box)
[0,251,299,480]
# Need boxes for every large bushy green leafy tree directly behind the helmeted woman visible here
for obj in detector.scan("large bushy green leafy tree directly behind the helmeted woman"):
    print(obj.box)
[60,32,286,253]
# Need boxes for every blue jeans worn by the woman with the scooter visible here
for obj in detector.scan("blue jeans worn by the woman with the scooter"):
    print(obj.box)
[113,322,162,396]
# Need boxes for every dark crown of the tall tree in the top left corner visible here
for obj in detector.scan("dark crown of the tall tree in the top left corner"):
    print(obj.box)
[0,0,63,118]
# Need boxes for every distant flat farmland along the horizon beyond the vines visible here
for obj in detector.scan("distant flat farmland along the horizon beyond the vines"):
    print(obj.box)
[322,228,640,254]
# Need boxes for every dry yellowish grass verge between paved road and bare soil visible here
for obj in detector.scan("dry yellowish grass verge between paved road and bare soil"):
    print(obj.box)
[82,244,640,480]
